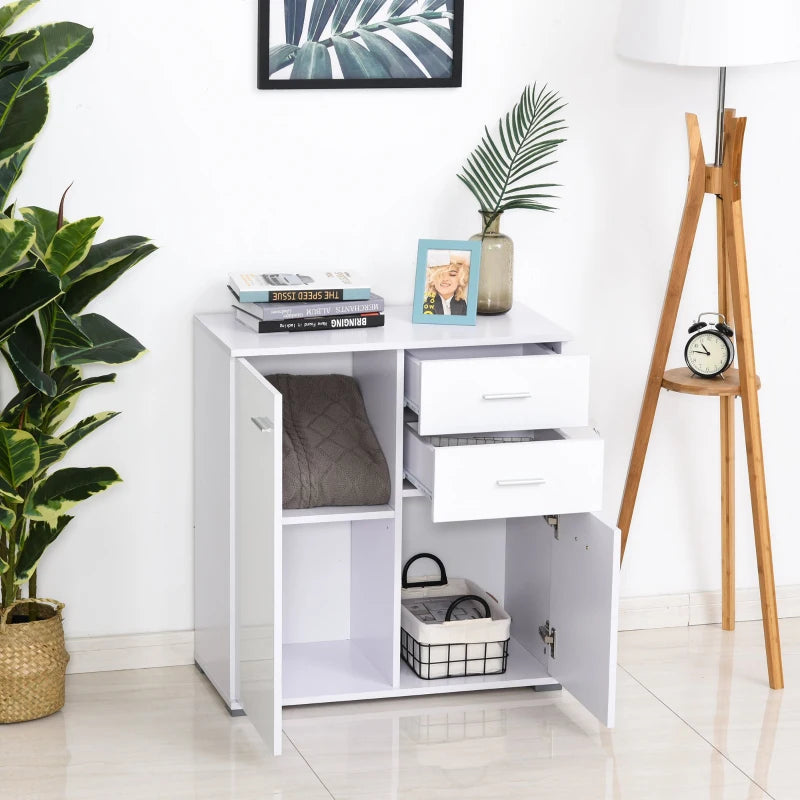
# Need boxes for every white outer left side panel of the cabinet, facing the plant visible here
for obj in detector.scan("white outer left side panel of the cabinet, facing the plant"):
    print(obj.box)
[193,321,238,707]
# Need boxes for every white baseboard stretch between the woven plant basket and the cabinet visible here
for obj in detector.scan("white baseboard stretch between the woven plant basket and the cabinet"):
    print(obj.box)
[67,631,194,674]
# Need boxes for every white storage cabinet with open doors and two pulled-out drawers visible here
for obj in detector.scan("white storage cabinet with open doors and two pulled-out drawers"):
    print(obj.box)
[194,305,620,753]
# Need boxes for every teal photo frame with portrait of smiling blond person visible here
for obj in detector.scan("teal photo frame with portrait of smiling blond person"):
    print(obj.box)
[411,239,481,325]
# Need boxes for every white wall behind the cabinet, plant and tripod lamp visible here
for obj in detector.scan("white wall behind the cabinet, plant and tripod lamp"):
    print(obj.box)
[10,0,800,636]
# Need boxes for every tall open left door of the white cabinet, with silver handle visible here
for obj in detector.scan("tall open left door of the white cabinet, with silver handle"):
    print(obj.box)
[234,359,283,755]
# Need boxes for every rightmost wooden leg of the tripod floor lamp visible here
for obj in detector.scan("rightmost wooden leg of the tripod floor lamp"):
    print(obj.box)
[722,117,783,689]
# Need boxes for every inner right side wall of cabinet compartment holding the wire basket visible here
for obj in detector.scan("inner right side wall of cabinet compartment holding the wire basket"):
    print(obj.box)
[505,517,553,666]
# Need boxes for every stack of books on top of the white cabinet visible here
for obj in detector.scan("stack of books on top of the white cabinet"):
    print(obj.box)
[228,270,384,333]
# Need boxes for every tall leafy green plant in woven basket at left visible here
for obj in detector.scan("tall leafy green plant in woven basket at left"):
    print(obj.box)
[0,0,155,722]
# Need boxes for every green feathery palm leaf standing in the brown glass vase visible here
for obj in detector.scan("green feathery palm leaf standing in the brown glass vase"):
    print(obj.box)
[458,84,566,234]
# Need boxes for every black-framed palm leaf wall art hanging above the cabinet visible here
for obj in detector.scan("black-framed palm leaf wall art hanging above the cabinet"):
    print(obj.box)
[258,0,464,89]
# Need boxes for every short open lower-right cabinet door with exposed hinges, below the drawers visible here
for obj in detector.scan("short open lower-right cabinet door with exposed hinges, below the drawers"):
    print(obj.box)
[548,514,620,728]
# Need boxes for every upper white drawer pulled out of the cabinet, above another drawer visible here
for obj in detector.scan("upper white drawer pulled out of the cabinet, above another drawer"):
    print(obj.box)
[405,345,589,436]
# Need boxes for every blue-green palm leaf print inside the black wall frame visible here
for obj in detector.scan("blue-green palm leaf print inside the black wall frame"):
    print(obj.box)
[269,0,455,80]
